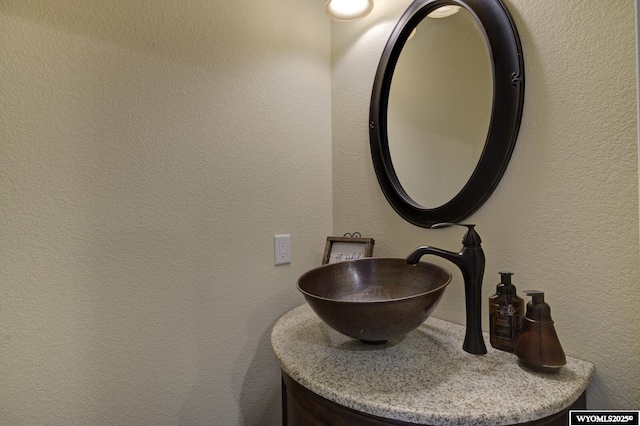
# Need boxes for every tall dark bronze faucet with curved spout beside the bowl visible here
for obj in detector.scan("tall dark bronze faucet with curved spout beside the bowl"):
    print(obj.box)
[407,223,487,355]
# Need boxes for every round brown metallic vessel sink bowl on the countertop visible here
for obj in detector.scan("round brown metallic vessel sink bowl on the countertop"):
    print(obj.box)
[298,257,451,343]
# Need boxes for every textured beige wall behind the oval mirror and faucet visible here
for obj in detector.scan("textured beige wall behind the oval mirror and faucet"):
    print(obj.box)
[332,0,640,409]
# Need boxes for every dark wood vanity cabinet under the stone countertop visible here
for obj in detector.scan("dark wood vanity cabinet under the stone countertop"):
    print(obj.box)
[282,372,586,426]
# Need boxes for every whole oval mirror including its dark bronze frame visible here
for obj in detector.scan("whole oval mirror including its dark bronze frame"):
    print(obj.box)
[370,0,524,227]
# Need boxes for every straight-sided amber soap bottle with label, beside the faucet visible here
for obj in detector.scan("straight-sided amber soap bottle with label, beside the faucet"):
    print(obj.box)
[489,272,524,352]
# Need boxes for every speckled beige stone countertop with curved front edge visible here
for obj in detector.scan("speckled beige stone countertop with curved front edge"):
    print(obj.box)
[271,304,595,426]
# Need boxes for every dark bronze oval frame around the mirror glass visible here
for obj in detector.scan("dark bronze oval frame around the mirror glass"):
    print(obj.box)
[369,0,524,228]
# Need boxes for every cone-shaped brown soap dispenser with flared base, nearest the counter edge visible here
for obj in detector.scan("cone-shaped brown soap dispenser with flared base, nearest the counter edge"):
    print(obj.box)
[516,290,567,373]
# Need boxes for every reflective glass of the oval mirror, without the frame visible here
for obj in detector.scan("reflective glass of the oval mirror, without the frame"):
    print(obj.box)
[387,9,493,208]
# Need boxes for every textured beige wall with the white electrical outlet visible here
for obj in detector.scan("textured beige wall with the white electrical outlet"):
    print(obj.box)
[0,0,332,426]
